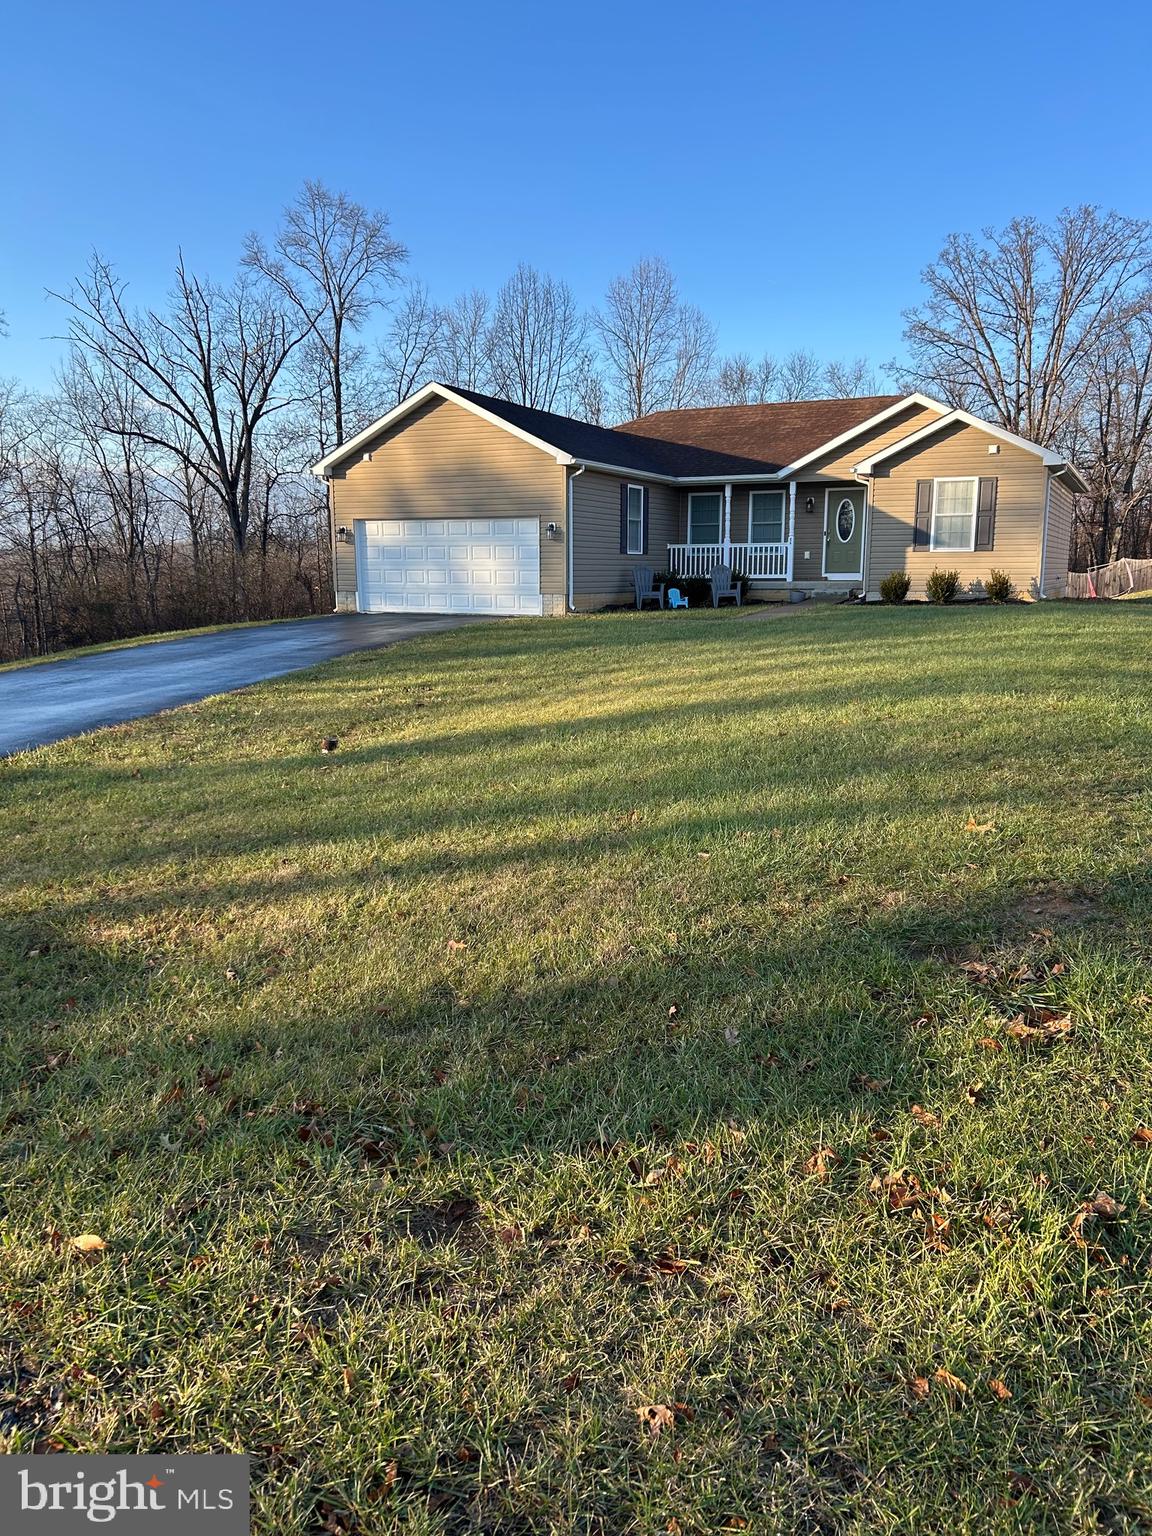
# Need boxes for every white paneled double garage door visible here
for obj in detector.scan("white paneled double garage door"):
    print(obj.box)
[356,518,544,613]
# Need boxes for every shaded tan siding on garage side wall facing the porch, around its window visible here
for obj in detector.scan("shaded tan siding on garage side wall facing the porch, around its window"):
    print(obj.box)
[571,470,680,608]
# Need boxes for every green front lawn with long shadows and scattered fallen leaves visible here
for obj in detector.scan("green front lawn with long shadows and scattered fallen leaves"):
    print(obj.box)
[0,604,1152,1536]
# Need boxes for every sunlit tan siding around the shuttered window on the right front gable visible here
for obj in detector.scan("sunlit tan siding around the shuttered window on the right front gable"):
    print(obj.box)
[866,427,1048,598]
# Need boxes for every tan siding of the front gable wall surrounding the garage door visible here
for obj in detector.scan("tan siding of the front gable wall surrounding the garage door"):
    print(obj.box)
[332,399,567,613]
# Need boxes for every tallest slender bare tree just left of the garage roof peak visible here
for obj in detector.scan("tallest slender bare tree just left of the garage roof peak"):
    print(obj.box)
[244,181,409,453]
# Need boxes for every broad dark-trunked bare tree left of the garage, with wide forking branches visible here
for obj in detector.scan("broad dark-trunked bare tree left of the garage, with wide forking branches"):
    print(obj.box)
[54,258,310,574]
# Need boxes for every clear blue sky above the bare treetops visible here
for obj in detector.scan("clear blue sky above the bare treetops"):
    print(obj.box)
[0,0,1152,386]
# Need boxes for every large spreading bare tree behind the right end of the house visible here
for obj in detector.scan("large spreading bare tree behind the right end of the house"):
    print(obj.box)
[899,206,1152,442]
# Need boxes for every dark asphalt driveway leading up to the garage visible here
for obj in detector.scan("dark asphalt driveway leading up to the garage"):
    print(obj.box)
[0,613,478,757]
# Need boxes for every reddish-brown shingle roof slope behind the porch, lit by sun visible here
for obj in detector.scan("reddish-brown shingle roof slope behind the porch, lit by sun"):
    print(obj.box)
[614,395,905,473]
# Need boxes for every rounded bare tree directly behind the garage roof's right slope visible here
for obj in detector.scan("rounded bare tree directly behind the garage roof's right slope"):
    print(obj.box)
[488,263,588,410]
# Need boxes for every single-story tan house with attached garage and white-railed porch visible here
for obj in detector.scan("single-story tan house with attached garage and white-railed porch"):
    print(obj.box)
[313,384,1084,614]
